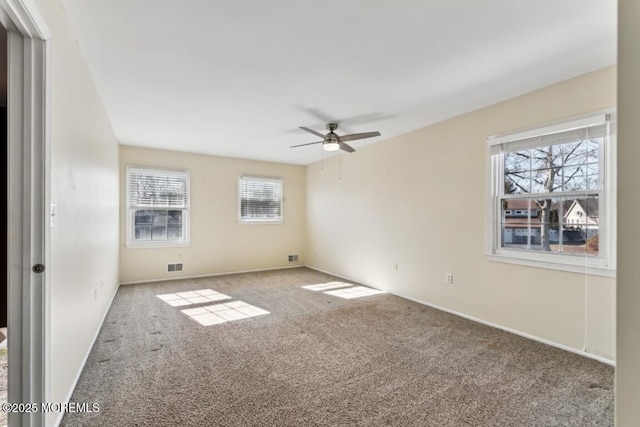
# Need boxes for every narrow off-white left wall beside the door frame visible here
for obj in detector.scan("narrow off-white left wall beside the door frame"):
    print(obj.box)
[38,1,119,425]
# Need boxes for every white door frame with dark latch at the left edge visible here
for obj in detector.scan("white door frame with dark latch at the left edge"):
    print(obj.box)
[0,0,50,426]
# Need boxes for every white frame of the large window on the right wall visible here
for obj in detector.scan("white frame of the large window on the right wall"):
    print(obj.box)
[486,109,616,277]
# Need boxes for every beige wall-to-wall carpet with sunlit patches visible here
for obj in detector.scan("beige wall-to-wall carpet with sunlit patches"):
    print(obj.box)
[62,268,614,427]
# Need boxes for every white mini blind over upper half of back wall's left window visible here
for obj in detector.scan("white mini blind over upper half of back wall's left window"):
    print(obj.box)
[128,168,189,209]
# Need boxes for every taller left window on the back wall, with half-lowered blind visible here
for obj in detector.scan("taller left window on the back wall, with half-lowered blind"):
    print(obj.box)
[127,166,189,247]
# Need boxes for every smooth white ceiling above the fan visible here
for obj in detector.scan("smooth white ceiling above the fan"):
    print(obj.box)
[62,0,617,164]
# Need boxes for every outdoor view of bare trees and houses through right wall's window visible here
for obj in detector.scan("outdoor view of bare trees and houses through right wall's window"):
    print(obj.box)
[502,129,603,254]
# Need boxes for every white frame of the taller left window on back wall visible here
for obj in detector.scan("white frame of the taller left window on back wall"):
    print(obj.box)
[125,165,191,248]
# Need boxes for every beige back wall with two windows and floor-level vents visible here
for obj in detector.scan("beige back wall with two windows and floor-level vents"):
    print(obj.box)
[120,146,305,283]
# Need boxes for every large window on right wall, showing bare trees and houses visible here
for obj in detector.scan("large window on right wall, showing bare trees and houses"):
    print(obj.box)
[487,114,615,275]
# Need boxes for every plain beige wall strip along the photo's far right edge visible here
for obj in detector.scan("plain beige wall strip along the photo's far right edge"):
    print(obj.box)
[616,0,640,427]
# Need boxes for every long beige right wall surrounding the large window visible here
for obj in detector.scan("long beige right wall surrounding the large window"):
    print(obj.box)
[306,67,616,360]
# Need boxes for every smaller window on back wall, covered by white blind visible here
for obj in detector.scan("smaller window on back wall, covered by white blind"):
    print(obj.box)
[238,176,282,223]
